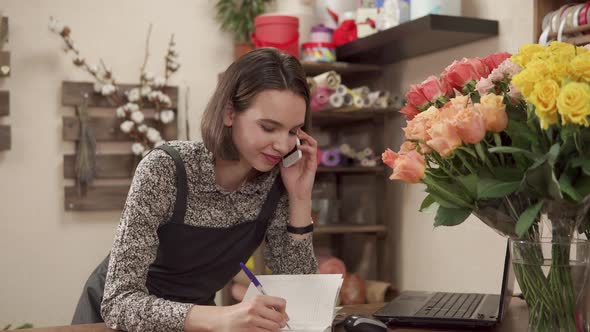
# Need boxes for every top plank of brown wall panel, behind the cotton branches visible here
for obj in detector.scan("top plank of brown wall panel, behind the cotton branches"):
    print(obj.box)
[61,81,178,109]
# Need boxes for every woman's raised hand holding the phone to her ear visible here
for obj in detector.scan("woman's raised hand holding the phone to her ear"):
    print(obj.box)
[281,129,318,200]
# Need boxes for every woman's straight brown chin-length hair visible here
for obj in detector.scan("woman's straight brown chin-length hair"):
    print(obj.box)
[201,48,310,160]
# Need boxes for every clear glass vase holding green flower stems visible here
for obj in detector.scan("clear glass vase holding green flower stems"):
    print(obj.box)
[510,238,590,332]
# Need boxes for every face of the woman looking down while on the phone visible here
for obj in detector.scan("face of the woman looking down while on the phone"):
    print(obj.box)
[224,90,305,172]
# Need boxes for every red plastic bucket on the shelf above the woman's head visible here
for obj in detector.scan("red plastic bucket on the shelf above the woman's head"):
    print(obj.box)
[252,14,299,58]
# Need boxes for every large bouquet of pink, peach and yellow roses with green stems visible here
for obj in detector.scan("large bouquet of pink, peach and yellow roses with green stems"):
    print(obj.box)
[382,42,590,331]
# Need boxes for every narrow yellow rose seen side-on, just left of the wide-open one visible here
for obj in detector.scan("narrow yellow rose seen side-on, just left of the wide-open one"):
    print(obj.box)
[529,79,559,129]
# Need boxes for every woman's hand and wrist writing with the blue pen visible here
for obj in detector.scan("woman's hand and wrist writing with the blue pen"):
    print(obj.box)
[185,295,289,332]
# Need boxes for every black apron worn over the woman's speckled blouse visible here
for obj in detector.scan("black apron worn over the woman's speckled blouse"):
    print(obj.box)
[72,145,284,324]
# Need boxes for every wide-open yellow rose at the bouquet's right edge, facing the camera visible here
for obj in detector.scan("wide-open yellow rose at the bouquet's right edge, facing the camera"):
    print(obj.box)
[557,82,590,127]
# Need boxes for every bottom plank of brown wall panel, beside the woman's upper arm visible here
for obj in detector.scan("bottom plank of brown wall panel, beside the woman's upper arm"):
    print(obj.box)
[64,185,129,211]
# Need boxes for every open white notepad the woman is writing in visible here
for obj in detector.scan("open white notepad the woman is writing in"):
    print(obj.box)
[244,274,342,332]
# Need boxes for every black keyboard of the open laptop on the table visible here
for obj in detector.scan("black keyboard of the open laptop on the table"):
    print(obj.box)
[415,292,484,319]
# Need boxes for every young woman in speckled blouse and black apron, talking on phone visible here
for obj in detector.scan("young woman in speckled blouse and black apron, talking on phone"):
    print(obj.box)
[75,48,317,331]
